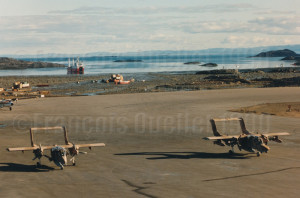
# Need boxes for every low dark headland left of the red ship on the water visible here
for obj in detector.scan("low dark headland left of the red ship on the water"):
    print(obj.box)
[0,57,65,69]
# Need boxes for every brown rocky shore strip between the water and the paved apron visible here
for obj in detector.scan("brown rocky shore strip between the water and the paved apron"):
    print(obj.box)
[0,67,300,98]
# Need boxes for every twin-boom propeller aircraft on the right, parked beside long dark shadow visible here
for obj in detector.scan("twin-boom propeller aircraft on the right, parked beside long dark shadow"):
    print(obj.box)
[203,118,289,156]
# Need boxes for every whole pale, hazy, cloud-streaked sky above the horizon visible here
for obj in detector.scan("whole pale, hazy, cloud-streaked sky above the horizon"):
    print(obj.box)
[0,0,300,54]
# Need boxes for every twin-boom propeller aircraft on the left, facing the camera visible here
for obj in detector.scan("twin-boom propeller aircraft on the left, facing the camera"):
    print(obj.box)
[7,126,105,169]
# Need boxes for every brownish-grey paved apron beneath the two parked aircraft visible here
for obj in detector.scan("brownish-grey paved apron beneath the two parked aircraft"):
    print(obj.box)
[0,87,300,198]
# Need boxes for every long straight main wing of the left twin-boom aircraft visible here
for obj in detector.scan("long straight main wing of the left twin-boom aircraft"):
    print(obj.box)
[7,143,105,151]
